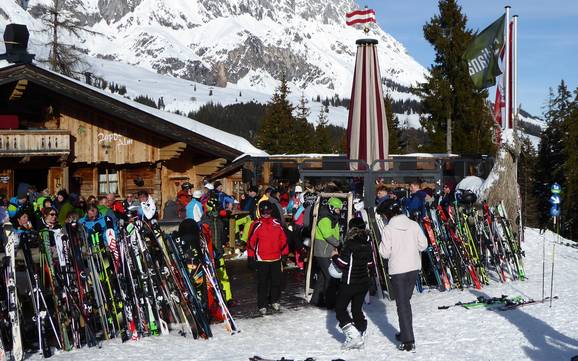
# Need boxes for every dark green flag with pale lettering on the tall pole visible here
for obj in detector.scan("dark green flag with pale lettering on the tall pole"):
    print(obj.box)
[463,14,506,89]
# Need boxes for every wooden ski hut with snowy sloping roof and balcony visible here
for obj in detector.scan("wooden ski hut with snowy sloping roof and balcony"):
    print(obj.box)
[0,61,266,217]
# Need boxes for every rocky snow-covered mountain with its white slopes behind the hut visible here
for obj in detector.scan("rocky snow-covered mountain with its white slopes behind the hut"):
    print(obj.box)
[0,0,544,136]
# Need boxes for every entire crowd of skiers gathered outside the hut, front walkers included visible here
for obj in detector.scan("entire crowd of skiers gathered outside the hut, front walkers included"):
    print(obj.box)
[0,176,455,351]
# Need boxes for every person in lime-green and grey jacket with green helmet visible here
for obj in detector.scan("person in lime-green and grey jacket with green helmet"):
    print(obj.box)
[311,197,343,308]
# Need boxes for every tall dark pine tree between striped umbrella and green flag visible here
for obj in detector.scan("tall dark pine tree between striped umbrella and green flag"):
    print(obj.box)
[416,0,495,154]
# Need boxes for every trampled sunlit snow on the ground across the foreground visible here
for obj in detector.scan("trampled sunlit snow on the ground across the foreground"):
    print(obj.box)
[25,229,578,361]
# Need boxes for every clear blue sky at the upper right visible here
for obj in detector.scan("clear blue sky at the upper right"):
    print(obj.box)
[364,0,578,116]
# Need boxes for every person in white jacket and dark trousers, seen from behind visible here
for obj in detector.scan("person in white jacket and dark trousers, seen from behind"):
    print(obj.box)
[377,200,427,352]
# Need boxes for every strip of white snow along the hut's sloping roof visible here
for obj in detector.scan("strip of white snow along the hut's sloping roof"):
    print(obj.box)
[0,60,268,156]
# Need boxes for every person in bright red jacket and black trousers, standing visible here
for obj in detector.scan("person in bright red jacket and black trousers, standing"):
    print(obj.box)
[247,201,289,315]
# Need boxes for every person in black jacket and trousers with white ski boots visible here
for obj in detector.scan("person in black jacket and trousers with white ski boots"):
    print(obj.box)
[330,218,373,349]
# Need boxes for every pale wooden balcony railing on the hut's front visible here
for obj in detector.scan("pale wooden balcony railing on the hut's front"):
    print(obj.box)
[0,129,70,157]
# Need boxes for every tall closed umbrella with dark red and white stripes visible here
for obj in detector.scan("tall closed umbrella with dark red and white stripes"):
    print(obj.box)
[347,39,389,170]
